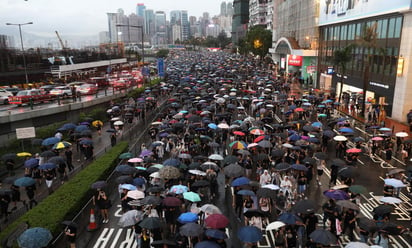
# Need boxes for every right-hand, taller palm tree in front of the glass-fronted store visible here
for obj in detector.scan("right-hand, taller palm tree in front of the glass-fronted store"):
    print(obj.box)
[357,22,378,116]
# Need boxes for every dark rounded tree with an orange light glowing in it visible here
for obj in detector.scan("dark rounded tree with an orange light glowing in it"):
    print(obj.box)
[244,26,272,59]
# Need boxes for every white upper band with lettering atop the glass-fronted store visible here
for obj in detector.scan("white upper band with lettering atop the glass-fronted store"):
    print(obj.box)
[319,0,412,26]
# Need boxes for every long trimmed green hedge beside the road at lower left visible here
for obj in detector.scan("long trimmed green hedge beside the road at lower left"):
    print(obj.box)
[0,142,128,245]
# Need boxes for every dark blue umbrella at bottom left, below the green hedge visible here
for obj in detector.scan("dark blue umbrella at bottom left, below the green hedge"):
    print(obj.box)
[17,227,53,248]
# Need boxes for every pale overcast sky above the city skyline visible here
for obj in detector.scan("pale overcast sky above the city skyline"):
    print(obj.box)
[0,0,227,36]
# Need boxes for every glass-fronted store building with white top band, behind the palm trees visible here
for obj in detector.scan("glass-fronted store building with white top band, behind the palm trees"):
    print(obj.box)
[319,0,412,121]
